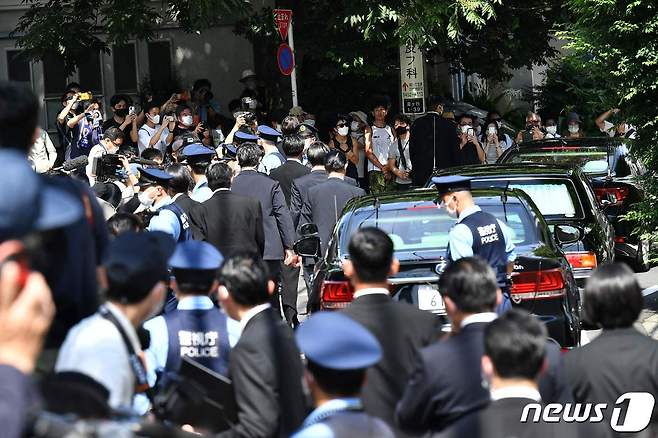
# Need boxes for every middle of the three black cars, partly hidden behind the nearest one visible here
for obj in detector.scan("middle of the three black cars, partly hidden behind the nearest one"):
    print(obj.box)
[428,164,615,288]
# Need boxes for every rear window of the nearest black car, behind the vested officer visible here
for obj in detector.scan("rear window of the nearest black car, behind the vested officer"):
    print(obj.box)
[340,197,539,260]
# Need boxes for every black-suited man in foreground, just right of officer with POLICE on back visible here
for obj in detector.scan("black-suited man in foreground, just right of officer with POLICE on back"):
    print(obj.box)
[218,256,308,438]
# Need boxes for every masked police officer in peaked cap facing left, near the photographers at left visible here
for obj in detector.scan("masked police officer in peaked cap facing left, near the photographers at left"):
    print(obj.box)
[139,168,192,242]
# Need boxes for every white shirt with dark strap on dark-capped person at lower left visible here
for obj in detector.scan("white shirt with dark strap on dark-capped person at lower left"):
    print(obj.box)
[55,303,142,409]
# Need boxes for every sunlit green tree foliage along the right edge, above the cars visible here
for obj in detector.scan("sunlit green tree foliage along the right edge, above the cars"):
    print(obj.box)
[560,0,658,243]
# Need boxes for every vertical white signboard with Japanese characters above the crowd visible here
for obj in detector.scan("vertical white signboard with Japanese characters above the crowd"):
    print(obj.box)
[400,41,425,114]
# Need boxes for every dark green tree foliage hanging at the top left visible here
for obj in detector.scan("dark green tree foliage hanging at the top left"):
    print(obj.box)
[14,0,250,73]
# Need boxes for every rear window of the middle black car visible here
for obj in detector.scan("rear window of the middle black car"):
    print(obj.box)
[471,178,584,219]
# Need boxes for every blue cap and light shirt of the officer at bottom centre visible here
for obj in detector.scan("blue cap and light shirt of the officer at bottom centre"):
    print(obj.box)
[293,312,394,438]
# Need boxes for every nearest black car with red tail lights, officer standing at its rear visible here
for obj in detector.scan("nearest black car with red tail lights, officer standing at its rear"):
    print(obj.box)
[296,189,580,347]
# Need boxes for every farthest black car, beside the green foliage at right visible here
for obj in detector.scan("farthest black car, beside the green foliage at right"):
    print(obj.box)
[498,137,651,272]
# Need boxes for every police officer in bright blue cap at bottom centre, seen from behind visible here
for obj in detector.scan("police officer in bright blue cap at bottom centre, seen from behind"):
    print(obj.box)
[293,312,394,438]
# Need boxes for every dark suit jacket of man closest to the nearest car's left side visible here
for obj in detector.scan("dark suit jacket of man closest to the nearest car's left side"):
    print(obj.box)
[299,178,366,254]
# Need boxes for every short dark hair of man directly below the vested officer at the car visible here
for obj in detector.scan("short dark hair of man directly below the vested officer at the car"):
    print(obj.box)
[439,256,498,313]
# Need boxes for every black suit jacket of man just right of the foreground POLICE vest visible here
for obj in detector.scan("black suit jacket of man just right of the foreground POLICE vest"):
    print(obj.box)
[219,309,308,438]
